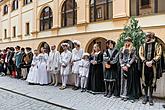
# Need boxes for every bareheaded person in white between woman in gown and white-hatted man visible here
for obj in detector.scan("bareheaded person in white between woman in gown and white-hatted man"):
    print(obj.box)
[47,45,60,86]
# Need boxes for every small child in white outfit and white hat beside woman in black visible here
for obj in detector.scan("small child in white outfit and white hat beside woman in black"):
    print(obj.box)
[79,53,90,92]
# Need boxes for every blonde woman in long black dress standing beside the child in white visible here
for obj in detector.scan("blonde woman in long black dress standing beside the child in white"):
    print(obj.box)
[87,44,105,94]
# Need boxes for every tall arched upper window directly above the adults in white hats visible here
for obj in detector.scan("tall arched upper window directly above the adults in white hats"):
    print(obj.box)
[61,0,77,27]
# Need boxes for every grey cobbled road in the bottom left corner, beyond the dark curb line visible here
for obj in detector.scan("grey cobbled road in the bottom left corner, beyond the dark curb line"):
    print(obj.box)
[0,90,66,110]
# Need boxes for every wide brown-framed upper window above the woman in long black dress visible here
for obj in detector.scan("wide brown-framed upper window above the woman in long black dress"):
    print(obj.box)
[90,0,113,22]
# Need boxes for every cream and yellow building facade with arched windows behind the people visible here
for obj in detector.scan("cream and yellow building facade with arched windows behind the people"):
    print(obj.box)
[0,0,165,96]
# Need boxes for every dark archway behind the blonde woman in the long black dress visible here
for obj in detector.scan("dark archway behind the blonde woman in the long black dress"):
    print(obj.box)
[85,37,107,53]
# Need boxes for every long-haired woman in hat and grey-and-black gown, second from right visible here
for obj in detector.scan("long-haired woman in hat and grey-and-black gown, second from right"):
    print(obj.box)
[119,37,140,103]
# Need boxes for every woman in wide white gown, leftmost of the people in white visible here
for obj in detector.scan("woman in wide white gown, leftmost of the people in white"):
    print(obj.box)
[26,50,39,85]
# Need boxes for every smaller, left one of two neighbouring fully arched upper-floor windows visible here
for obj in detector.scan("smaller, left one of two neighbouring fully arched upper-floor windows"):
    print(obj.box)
[40,7,53,31]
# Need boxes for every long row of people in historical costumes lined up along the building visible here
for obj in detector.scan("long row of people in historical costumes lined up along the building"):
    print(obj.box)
[0,32,162,106]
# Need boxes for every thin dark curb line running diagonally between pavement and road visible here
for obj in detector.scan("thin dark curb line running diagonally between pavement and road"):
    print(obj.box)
[0,87,76,110]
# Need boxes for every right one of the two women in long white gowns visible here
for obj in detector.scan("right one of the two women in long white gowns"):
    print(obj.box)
[38,47,49,85]
